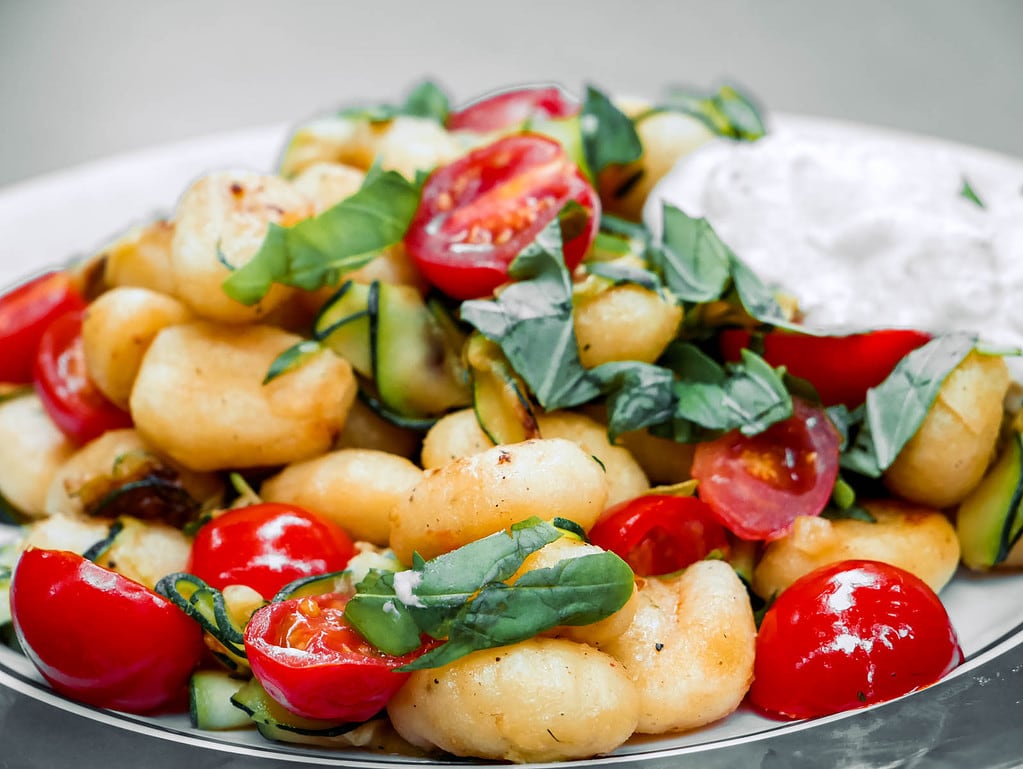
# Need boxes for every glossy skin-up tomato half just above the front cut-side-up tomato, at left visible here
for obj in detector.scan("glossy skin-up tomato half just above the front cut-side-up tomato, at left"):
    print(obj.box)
[188,502,355,600]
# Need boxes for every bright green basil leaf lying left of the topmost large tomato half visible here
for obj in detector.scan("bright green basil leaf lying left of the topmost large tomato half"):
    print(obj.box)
[223,171,419,305]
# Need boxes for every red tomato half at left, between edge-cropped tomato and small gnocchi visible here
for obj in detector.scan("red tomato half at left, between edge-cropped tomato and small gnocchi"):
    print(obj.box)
[34,312,132,444]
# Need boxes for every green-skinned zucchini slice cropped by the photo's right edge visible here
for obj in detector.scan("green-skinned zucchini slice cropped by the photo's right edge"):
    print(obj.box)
[955,433,1023,571]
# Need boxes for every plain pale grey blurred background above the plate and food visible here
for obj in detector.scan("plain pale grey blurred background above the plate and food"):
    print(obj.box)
[0,0,1023,185]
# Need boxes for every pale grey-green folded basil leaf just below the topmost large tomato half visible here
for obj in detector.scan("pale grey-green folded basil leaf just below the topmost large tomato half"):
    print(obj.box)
[461,220,599,411]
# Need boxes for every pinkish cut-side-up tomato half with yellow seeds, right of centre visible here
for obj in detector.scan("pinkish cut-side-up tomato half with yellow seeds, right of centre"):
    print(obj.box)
[692,398,840,540]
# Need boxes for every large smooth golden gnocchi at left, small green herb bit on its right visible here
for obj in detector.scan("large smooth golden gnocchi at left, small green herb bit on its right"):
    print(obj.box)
[131,322,355,470]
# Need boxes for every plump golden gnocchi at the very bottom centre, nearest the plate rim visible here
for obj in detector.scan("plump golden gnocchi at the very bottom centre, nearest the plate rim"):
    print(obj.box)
[388,638,638,762]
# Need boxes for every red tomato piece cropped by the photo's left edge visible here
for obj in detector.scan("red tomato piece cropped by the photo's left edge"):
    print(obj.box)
[0,272,85,385]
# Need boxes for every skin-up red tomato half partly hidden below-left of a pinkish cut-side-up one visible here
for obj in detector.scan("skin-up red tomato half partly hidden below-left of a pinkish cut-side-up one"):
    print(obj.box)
[589,494,729,577]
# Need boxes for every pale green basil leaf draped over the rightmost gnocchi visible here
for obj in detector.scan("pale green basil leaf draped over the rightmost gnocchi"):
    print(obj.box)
[841,333,976,478]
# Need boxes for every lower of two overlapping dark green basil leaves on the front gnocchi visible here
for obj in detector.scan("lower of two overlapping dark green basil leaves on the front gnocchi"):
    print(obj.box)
[398,552,634,671]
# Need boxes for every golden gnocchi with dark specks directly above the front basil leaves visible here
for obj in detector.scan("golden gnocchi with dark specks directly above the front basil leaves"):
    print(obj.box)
[391,438,608,563]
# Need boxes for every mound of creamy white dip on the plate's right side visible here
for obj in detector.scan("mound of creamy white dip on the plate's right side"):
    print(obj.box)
[644,123,1023,346]
